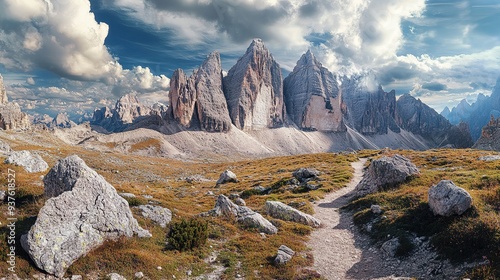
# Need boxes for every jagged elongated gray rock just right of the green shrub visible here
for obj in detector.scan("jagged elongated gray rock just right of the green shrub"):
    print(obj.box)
[208,194,278,234]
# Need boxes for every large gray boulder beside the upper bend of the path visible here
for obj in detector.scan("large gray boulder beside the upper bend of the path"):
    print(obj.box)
[355,155,419,197]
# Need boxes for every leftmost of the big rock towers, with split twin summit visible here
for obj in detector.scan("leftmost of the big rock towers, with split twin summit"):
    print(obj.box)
[169,52,231,132]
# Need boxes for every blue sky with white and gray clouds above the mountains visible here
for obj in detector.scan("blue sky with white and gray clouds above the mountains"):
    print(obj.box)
[0,0,500,119]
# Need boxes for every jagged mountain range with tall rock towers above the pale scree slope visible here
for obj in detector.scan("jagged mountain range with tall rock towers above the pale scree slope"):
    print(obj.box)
[92,39,472,149]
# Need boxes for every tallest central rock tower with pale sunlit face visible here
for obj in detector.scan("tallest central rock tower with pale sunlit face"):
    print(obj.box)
[224,39,286,130]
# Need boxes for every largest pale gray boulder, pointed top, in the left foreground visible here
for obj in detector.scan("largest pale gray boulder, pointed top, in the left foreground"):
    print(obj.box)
[21,155,151,277]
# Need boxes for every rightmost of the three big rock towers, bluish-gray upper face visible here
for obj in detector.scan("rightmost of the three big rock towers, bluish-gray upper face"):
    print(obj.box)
[283,51,346,132]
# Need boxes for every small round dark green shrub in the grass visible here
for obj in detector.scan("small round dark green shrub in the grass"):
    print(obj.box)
[167,219,208,251]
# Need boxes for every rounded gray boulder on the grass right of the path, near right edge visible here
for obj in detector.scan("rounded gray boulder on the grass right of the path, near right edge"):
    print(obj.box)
[428,180,472,216]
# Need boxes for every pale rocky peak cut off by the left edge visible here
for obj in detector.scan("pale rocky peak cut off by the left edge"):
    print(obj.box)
[0,75,31,130]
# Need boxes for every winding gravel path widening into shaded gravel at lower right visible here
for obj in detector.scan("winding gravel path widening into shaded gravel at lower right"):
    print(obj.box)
[307,159,477,280]
